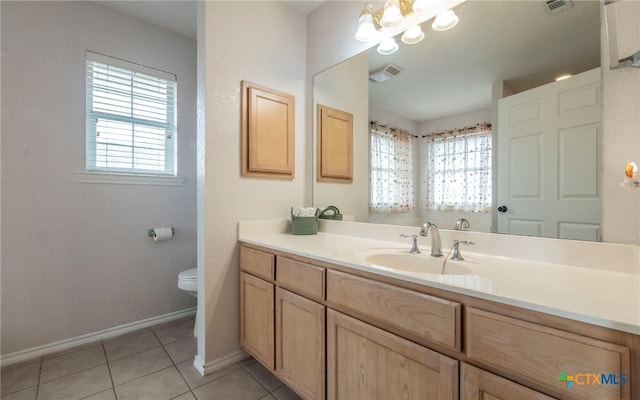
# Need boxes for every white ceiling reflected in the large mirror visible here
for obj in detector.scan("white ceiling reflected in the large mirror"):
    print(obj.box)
[369,0,600,122]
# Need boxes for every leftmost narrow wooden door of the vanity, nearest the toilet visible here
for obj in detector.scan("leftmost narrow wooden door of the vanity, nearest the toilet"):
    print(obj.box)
[240,272,275,371]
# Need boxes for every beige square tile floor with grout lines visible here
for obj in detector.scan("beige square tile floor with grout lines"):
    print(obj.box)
[0,318,299,400]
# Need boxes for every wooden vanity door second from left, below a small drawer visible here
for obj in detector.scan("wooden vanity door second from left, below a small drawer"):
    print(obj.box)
[276,288,325,399]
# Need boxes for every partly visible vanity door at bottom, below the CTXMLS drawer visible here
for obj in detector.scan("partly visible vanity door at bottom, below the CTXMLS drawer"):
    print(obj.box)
[460,363,554,400]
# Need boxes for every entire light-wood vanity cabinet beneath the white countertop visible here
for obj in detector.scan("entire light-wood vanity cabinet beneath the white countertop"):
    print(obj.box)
[240,246,640,400]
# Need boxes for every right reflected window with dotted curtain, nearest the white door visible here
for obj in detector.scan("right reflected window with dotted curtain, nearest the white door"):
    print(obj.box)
[426,124,491,212]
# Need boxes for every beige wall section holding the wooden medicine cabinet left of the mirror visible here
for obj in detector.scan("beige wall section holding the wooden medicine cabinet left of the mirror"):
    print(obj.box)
[196,1,307,371]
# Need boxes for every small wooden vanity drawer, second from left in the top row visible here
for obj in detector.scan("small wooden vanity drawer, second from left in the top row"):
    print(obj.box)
[276,257,325,300]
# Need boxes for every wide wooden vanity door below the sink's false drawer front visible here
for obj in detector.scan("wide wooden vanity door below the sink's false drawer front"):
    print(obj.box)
[327,309,458,400]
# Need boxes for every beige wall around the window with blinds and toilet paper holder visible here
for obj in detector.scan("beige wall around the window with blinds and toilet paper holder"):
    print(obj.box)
[0,2,196,357]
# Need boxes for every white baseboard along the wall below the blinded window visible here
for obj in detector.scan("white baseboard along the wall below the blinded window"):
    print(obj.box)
[0,307,196,367]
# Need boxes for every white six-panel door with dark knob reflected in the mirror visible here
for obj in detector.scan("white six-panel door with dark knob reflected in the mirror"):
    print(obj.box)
[498,68,602,240]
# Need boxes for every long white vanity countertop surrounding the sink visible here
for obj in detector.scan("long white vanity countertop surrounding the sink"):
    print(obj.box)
[239,222,640,335]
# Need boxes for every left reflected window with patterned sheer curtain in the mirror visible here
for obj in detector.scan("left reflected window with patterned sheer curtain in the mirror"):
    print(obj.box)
[369,122,415,213]
